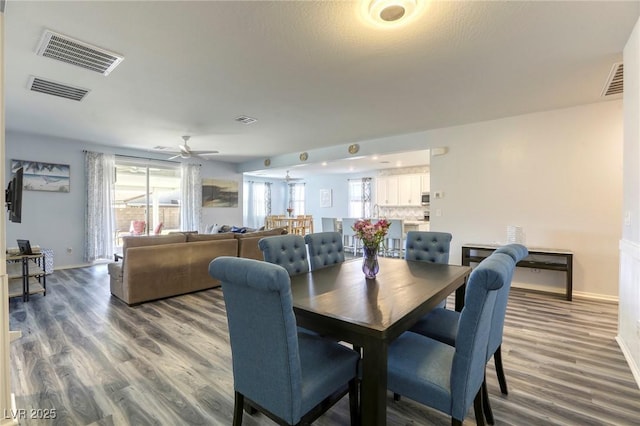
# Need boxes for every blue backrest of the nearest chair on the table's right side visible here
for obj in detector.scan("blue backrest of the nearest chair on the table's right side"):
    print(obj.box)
[451,253,515,419]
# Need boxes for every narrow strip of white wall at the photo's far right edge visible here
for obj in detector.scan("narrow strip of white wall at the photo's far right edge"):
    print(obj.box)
[618,16,640,386]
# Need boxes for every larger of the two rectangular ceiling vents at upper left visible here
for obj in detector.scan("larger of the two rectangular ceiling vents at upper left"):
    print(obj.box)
[36,30,124,75]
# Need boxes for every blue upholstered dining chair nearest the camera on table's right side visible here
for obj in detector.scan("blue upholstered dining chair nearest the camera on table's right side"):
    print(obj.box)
[387,254,514,425]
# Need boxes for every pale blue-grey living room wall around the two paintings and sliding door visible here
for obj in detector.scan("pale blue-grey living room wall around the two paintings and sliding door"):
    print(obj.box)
[4,132,242,268]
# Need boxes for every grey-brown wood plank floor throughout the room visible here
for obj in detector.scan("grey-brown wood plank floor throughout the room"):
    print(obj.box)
[9,265,640,426]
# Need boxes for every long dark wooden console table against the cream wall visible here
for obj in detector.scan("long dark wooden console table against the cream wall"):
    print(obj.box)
[462,244,573,301]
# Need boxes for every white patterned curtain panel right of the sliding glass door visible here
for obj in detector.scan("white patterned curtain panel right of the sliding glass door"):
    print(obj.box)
[180,163,202,231]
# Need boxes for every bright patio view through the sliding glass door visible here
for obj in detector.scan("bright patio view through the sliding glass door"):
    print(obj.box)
[113,157,181,252]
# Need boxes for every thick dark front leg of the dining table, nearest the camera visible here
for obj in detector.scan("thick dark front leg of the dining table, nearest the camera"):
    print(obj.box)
[359,339,388,426]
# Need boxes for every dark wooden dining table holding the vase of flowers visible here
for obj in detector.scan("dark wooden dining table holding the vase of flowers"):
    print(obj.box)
[291,257,471,426]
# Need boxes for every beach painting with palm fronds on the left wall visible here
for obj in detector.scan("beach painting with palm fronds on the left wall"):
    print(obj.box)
[11,160,70,192]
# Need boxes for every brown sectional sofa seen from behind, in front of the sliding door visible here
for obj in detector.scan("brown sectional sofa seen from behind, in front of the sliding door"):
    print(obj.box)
[108,228,286,305]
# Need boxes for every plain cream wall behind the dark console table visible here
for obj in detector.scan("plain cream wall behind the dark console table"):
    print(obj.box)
[425,101,623,298]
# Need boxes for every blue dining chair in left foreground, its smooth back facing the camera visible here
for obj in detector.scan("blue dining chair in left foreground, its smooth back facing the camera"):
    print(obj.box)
[209,256,359,426]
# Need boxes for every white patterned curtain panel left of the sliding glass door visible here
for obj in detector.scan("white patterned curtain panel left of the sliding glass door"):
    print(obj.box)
[84,151,116,262]
